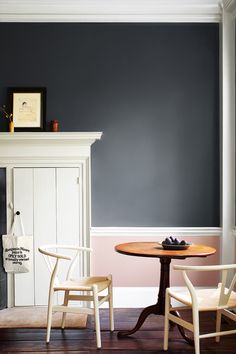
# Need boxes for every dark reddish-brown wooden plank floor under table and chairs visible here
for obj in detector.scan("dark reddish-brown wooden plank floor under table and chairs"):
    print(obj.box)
[0,309,236,354]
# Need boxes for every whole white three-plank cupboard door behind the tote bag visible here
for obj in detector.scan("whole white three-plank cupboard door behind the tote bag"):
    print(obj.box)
[14,168,81,306]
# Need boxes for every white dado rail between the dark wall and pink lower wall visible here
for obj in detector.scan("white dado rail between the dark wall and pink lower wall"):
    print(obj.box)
[90,227,222,238]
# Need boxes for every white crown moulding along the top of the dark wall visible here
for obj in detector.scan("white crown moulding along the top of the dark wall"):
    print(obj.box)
[0,0,221,22]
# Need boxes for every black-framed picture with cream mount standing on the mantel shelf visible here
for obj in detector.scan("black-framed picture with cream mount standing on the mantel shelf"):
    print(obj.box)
[9,87,46,131]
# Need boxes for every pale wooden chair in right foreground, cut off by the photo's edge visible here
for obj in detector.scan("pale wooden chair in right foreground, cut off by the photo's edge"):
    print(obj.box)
[164,264,236,354]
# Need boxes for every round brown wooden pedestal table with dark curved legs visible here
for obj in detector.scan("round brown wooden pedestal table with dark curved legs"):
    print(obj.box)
[115,242,216,344]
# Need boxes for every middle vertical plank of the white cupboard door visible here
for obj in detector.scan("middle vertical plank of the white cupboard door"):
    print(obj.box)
[33,168,56,305]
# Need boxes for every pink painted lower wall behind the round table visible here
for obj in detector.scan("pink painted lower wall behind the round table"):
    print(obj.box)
[91,236,220,287]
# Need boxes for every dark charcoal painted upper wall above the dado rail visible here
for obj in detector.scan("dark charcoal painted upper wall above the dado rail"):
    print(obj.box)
[0,23,219,226]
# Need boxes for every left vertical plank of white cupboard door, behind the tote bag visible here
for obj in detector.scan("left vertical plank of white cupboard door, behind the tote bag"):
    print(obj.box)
[13,168,35,306]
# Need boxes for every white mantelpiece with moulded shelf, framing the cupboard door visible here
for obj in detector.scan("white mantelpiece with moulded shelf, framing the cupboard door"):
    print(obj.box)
[0,132,102,307]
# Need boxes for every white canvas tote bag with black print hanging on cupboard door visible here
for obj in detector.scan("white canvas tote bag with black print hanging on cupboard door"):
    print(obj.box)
[2,211,33,273]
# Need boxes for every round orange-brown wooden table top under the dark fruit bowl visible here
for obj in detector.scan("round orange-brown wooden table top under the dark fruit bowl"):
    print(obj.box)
[115,242,216,259]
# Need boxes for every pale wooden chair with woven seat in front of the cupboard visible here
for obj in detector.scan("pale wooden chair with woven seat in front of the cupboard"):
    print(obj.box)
[38,245,114,348]
